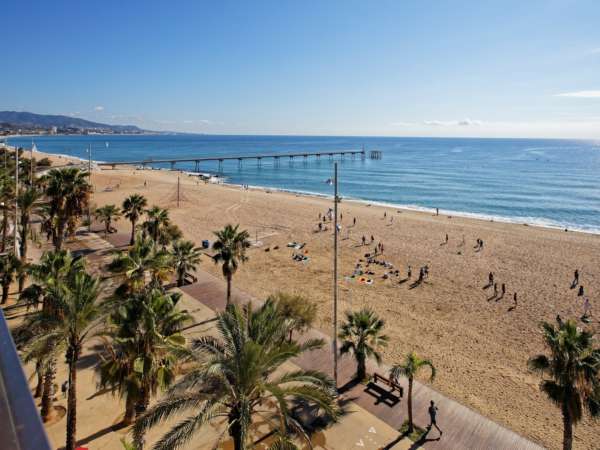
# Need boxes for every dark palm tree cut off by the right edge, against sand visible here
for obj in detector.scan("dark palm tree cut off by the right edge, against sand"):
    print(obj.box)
[528,320,600,450]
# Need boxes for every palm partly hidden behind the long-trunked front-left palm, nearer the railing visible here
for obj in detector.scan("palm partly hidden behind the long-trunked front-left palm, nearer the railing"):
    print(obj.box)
[15,250,85,422]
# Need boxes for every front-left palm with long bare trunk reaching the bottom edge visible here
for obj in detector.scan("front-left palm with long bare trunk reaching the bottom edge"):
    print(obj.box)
[22,271,102,450]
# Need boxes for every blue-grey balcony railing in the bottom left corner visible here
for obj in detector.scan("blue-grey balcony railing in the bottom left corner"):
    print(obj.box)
[0,310,50,450]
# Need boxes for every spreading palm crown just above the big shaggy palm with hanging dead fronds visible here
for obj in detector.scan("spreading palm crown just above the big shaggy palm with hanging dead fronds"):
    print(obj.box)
[108,234,173,291]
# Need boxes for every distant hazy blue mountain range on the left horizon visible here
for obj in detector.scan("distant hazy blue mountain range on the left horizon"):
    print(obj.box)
[0,111,146,134]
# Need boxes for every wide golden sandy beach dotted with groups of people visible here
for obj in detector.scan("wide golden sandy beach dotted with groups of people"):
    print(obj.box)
[25,149,600,449]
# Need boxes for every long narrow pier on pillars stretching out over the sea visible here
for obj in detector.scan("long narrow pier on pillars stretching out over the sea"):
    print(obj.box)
[97,149,370,172]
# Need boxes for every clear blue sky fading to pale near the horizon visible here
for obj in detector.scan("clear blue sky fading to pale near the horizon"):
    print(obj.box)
[0,0,600,139]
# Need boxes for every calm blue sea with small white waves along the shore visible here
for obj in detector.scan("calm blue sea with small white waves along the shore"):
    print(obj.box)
[9,135,600,232]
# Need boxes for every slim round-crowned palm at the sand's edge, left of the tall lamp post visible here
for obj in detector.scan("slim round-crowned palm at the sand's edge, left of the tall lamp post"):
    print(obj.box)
[213,225,250,305]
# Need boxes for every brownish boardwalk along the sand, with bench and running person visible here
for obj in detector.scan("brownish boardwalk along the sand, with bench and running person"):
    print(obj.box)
[102,235,543,450]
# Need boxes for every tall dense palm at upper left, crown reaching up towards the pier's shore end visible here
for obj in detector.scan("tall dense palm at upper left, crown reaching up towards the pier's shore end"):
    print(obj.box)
[43,167,91,250]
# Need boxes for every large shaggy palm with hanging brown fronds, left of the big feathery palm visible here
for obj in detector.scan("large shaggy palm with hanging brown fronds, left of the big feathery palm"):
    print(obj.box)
[98,289,190,425]
